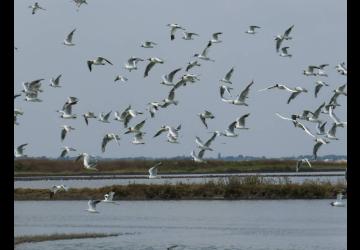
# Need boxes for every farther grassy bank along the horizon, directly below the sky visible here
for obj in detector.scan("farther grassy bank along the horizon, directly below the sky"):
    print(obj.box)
[14,158,346,176]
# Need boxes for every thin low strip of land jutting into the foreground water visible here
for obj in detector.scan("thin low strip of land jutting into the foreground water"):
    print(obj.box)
[14,233,118,245]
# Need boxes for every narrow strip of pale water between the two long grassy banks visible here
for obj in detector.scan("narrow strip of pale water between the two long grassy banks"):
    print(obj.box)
[14,172,345,188]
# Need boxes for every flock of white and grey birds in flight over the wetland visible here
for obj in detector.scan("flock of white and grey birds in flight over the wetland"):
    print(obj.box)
[14,0,347,212]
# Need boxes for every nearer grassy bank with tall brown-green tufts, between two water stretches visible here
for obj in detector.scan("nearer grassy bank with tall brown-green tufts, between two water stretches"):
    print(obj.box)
[14,176,346,200]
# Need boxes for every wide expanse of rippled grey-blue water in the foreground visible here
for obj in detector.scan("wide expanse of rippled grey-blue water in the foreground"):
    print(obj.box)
[14,200,347,250]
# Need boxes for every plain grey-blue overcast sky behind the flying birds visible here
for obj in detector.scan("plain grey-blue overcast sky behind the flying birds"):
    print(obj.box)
[14,0,347,158]
